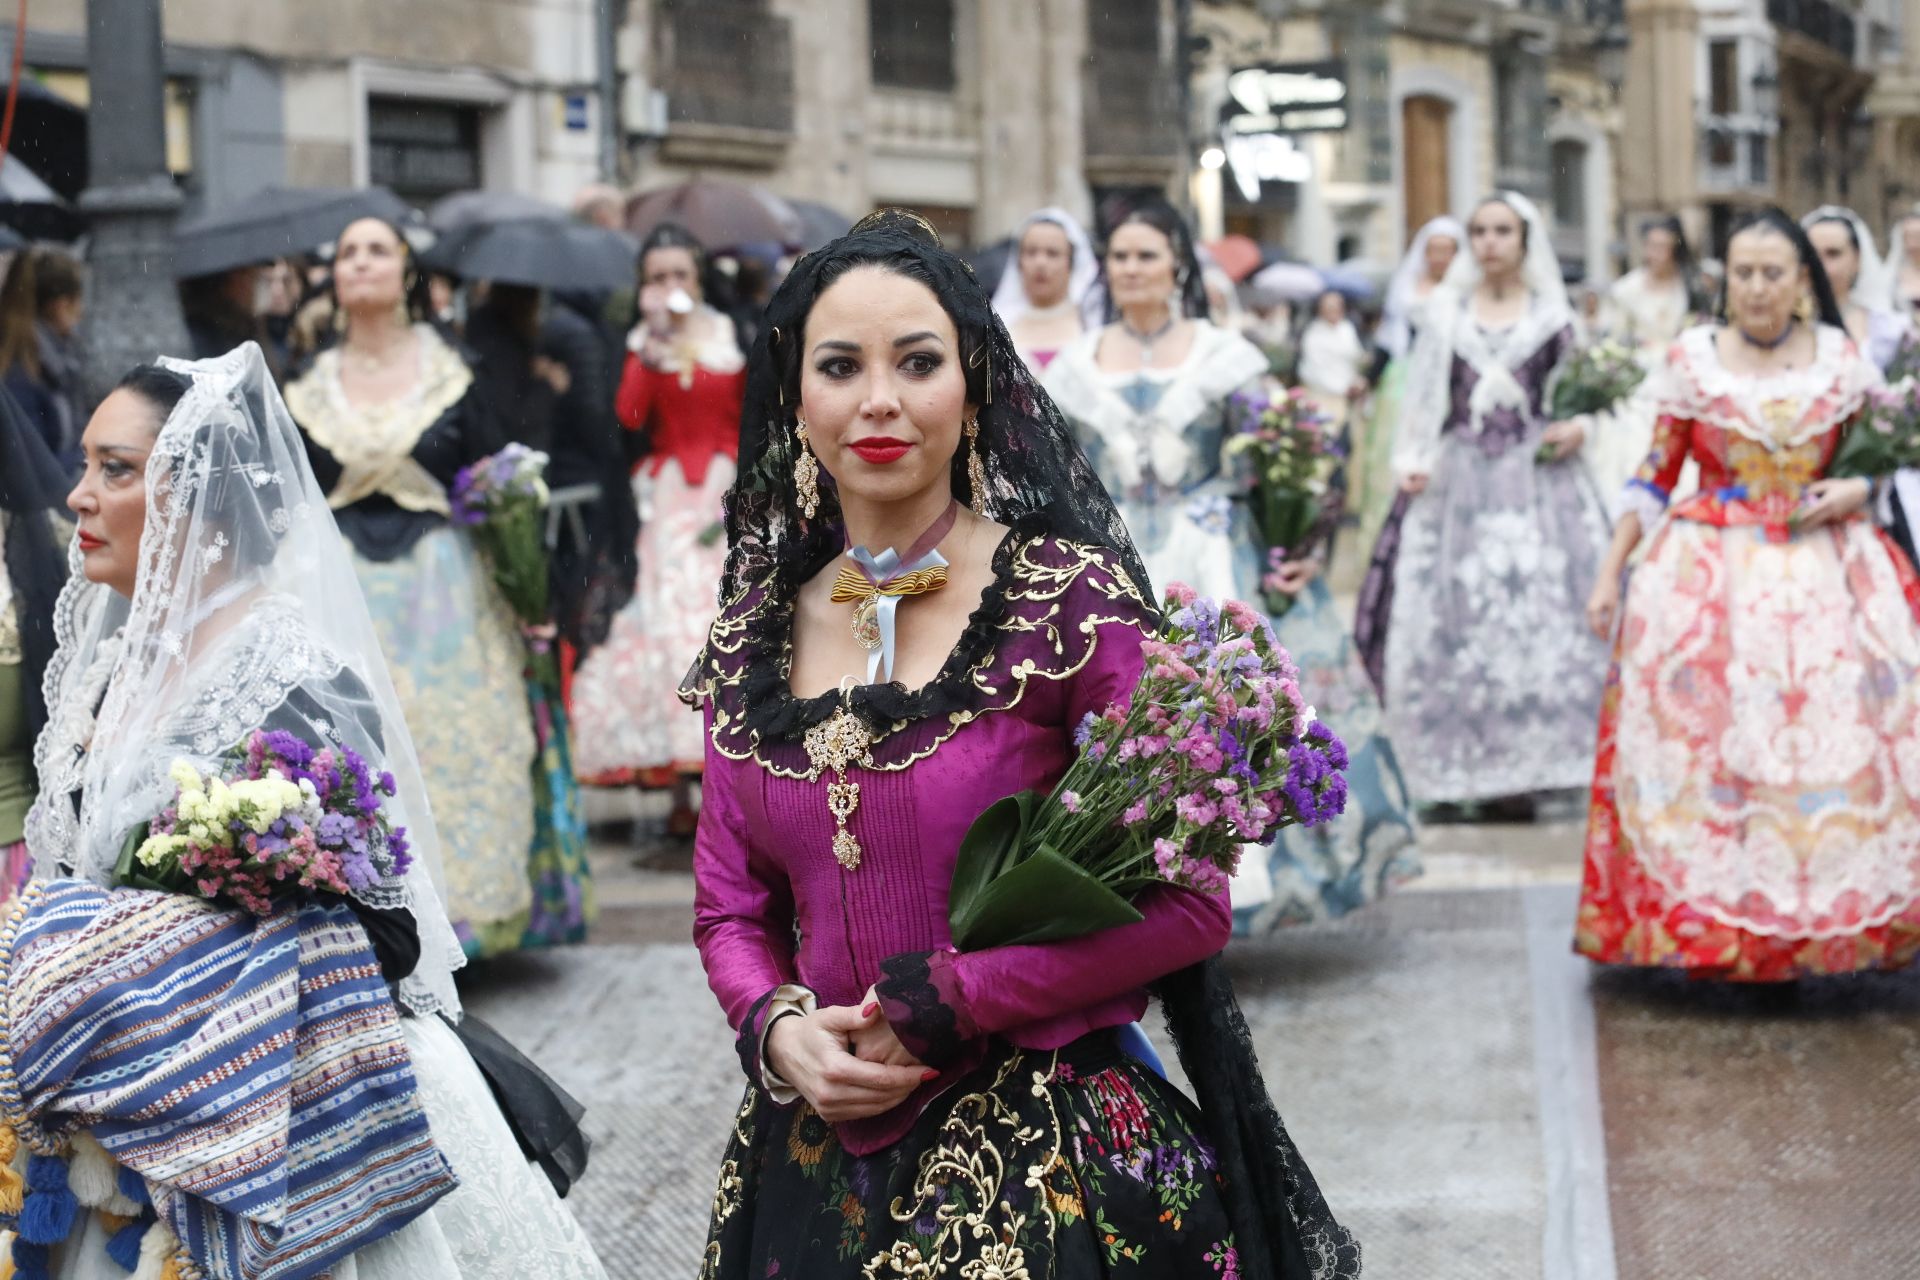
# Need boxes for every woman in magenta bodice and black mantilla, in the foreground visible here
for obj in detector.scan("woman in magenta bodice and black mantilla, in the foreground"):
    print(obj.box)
[691,211,1359,1280]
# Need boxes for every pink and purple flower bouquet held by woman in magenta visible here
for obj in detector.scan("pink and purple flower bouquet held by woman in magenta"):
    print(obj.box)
[948,583,1346,952]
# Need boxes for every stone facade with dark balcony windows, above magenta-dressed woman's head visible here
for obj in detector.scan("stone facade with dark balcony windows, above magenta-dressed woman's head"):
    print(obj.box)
[620,0,1185,244]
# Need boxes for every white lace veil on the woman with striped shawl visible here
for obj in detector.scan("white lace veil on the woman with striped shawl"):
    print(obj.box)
[27,342,464,1013]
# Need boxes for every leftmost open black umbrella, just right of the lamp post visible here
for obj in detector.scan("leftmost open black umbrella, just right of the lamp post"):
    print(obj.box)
[173,186,415,280]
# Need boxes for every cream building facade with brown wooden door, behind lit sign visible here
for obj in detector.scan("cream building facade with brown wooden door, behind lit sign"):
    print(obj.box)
[1192,0,1622,280]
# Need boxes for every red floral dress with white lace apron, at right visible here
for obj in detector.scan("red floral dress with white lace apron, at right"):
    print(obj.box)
[1574,328,1920,983]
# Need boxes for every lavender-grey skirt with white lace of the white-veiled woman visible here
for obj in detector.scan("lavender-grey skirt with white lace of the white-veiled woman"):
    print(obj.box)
[1359,428,1609,804]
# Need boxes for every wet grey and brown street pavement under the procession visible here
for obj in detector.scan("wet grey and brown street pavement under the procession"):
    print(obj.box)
[467,798,1920,1280]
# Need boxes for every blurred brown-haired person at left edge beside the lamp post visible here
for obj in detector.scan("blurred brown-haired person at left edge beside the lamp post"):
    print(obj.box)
[0,249,86,472]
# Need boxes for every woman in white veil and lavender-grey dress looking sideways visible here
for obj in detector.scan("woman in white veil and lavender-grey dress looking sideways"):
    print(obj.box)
[1356,192,1607,814]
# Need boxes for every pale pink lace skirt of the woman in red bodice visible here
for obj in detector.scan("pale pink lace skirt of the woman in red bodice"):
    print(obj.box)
[572,457,733,783]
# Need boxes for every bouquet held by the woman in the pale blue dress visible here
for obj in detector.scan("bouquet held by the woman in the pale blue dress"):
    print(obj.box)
[1227,388,1344,618]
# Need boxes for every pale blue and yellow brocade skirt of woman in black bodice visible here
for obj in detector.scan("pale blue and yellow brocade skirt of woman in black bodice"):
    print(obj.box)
[353,526,536,942]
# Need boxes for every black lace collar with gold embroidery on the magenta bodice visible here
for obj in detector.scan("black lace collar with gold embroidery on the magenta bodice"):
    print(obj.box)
[685,516,1152,756]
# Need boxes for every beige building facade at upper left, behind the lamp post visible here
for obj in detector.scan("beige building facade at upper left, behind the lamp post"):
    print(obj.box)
[0,0,599,211]
